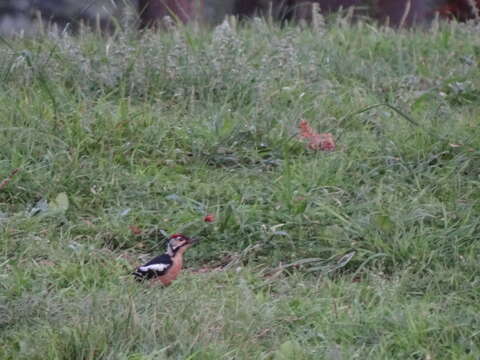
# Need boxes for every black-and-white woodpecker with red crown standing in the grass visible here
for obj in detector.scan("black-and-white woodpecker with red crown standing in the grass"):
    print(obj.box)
[132,234,197,286]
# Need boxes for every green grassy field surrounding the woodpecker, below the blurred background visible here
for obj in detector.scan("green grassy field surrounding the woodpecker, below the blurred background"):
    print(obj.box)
[0,20,480,360]
